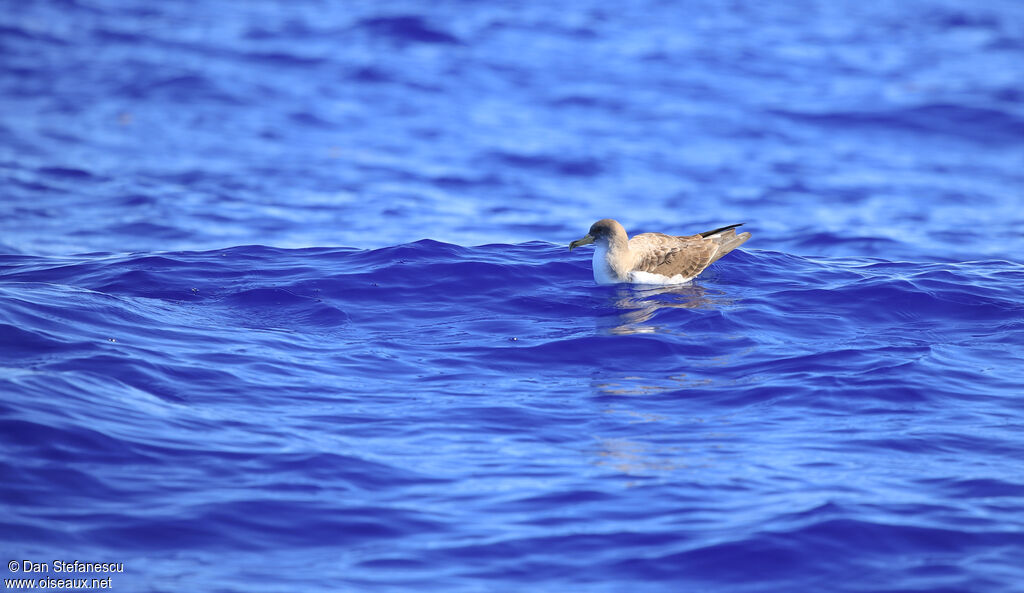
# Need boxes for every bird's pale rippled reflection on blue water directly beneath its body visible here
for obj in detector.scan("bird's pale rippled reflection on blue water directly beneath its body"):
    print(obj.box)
[607,283,731,335]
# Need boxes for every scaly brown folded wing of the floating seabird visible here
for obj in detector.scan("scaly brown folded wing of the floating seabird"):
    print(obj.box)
[630,232,719,278]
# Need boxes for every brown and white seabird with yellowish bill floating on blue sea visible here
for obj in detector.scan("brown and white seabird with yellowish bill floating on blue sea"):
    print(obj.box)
[569,218,751,284]
